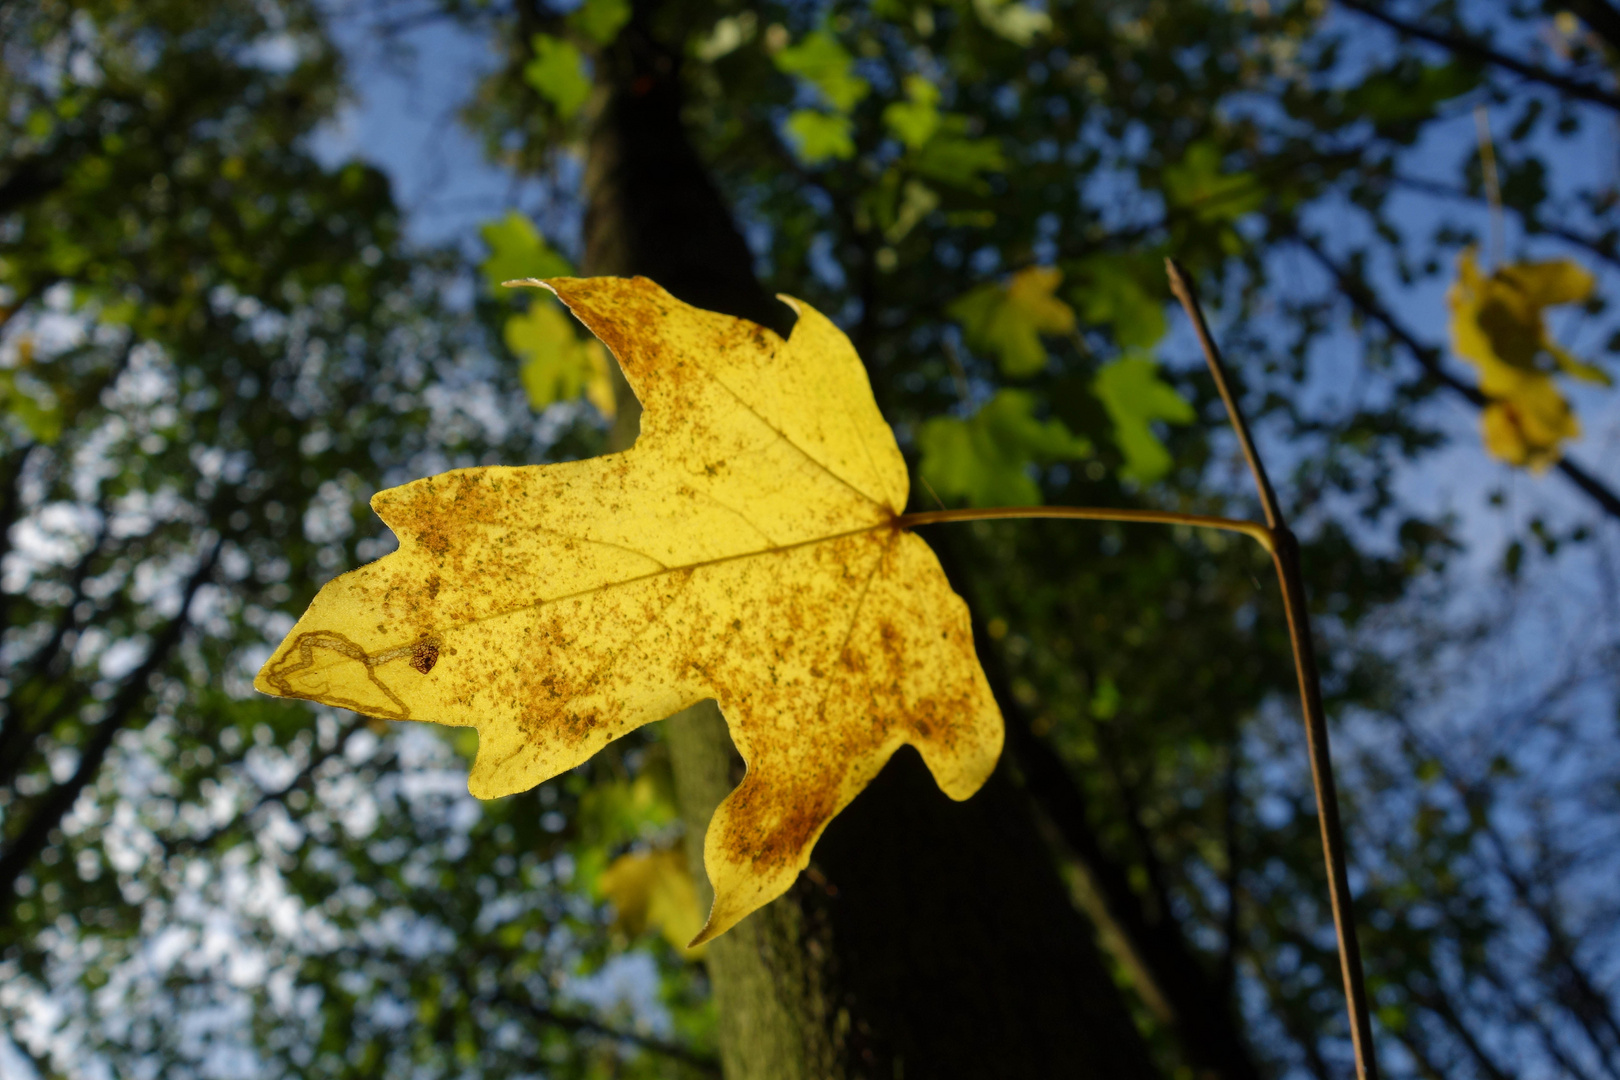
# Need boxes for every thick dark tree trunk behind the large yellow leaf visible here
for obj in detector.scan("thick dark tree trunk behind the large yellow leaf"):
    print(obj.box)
[585,5,1158,1080]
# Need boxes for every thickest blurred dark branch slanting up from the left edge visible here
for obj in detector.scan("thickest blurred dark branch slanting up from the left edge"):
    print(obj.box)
[0,539,220,926]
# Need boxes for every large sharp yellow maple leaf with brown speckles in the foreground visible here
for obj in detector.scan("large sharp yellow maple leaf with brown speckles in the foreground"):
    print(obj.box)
[254,279,1001,944]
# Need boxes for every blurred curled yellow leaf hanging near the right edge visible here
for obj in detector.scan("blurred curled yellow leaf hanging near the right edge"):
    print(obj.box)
[1447,248,1609,471]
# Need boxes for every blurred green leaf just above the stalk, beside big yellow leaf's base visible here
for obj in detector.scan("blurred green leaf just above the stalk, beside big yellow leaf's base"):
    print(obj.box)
[917,390,1092,507]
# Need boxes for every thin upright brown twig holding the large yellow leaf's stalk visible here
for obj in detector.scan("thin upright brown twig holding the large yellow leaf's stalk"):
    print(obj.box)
[1165,259,1379,1080]
